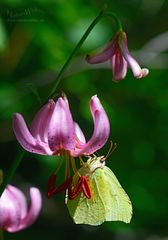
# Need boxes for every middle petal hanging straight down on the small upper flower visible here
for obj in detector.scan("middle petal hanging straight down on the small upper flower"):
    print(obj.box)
[111,50,127,82]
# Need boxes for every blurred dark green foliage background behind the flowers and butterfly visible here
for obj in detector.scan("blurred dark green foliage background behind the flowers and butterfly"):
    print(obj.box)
[0,0,168,240]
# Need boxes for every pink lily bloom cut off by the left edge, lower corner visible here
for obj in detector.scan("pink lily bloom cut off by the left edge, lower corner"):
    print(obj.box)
[0,185,42,232]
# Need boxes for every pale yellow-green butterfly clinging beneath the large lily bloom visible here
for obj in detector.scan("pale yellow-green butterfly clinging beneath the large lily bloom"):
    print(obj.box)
[67,156,132,225]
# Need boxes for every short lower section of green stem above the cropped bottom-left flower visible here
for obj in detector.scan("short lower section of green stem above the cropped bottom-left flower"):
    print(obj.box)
[0,149,26,196]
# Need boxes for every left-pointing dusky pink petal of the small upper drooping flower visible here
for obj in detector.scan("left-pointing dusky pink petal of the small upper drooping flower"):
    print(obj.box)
[86,34,117,64]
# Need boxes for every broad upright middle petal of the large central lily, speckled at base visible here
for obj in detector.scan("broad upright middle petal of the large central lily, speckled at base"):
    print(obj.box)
[48,97,75,152]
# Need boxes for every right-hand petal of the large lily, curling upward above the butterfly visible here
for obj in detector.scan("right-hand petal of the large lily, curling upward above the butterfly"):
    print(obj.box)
[72,95,110,156]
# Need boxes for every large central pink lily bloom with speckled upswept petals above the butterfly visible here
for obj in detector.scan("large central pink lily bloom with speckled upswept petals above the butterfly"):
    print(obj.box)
[13,95,110,156]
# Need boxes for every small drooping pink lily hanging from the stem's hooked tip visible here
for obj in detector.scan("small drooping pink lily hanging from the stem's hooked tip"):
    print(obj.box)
[86,31,149,82]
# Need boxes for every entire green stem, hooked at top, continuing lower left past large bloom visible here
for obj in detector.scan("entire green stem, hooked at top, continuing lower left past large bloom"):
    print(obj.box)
[0,6,122,196]
